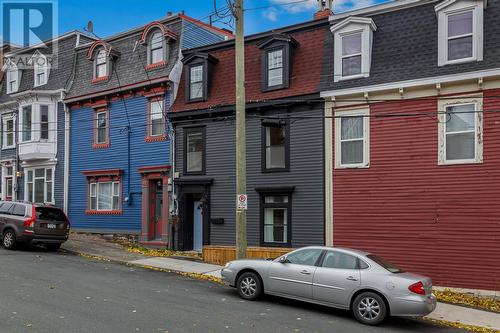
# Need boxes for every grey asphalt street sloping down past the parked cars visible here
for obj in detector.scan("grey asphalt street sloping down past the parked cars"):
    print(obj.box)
[0,248,463,333]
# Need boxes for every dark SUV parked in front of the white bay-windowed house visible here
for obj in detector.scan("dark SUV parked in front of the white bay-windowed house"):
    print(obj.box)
[0,201,70,251]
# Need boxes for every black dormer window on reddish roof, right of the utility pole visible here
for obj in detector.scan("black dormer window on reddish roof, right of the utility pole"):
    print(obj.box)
[258,34,299,91]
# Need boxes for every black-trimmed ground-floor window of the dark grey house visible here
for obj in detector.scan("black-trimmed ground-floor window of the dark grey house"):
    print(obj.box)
[263,195,290,245]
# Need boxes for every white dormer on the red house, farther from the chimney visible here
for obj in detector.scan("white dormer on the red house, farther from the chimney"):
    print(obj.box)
[435,0,485,66]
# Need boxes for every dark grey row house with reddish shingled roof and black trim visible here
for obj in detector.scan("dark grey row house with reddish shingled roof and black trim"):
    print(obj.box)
[168,9,331,263]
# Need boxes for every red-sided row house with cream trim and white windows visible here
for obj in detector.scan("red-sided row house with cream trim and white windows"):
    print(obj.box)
[321,0,500,290]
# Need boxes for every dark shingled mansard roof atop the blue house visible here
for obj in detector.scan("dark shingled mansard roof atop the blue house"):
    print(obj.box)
[66,14,233,103]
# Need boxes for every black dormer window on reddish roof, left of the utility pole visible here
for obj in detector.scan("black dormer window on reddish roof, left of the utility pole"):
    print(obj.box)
[182,53,217,102]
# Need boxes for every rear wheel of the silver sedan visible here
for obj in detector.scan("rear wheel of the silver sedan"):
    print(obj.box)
[352,292,387,325]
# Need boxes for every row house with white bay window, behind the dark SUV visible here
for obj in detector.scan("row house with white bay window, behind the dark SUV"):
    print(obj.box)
[0,31,94,207]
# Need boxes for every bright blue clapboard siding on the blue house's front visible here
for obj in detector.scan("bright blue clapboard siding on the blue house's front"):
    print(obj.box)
[68,92,170,234]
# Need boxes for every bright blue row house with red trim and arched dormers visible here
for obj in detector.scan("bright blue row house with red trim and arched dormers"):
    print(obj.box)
[65,14,232,245]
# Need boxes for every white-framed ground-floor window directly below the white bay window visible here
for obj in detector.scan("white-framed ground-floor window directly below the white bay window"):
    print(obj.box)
[25,168,54,203]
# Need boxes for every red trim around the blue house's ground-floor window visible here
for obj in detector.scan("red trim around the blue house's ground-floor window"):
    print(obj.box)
[82,169,123,215]
